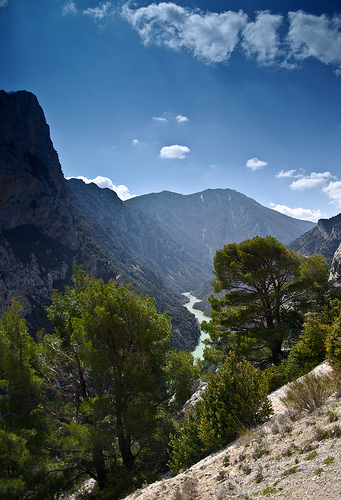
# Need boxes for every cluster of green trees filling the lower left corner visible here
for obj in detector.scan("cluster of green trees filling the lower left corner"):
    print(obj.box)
[0,269,196,498]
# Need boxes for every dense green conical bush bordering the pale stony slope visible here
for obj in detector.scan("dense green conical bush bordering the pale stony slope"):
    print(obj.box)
[169,353,272,473]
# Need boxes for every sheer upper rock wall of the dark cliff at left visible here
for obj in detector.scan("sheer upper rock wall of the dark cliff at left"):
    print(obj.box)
[0,91,79,249]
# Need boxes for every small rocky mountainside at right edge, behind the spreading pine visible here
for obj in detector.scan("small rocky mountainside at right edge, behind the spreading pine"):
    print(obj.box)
[288,214,341,265]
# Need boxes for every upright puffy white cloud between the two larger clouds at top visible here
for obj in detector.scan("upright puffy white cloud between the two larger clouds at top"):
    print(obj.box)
[242,11,283,64]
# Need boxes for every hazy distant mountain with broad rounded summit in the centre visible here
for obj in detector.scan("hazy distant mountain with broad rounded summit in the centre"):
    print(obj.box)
[124,189,314,270]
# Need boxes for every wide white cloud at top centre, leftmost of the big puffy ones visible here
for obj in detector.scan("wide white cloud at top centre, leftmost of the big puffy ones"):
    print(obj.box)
[122,2,247,64]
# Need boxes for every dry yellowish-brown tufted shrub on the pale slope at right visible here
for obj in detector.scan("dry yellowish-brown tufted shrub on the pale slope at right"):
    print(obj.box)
[282,373,333,412]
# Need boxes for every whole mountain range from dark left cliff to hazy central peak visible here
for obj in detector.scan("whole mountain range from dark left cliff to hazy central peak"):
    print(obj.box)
[0,91,313,350]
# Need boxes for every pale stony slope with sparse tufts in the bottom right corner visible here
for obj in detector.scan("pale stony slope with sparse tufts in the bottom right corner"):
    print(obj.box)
[126,365,341,500]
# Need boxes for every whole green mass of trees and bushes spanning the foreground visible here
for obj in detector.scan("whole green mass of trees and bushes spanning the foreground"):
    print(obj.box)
[0,237,341,500]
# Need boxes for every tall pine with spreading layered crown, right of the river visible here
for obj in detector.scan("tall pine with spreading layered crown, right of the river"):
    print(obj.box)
[202,236,303,363]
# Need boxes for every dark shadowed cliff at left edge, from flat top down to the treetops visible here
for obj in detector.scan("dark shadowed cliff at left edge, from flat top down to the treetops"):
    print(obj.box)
[0,91,105,331]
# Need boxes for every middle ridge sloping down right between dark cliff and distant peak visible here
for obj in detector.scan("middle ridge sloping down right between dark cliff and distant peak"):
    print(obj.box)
[67,179,211,292]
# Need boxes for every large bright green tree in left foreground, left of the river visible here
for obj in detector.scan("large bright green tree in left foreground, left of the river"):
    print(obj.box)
[2,269,195,498]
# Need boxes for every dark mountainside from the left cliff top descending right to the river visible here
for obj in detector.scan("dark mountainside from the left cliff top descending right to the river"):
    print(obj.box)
[0,91,200,350]
